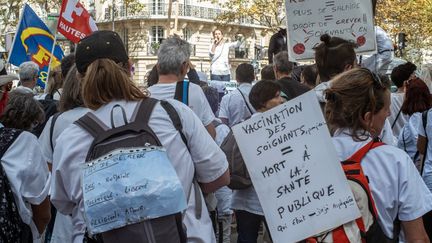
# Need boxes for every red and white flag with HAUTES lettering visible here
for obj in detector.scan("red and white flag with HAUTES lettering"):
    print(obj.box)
[57,0,97,43]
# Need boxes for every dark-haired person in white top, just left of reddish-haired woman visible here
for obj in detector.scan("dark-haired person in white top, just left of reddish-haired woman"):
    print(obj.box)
[388,62,417,136]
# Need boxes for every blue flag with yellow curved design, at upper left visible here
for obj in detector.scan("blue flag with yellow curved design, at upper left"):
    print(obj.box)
[9,4,64,88]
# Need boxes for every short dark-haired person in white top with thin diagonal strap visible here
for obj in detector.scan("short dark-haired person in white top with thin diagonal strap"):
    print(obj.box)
[219,63,255,127]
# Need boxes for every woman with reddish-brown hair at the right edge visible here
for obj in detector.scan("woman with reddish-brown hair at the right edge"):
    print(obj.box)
[398,78,432,169]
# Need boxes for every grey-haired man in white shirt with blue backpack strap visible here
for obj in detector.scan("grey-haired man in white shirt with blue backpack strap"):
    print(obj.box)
[149,37,216,138]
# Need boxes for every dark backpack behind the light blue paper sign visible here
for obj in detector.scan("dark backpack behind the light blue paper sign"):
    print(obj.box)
[75,98,186,243]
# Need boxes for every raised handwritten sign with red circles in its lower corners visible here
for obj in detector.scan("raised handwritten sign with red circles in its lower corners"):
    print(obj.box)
[285,0,376,61]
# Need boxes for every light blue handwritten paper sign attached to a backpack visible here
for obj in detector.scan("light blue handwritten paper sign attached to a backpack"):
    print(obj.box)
[82,146,186,234]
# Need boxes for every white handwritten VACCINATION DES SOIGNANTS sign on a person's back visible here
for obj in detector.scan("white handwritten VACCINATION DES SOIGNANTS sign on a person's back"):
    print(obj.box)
[233,91,360,243]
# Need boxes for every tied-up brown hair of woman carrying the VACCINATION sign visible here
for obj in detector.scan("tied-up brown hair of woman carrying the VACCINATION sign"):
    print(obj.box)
[325,68,389,141]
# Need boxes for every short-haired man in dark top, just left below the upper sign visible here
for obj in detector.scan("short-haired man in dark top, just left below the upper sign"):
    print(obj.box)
[273,51,310,101]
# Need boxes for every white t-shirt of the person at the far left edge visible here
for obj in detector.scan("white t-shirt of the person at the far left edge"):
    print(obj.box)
[0,123,51,242]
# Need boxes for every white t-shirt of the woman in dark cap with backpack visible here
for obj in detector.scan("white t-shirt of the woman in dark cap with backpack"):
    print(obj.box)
[51,99,228,243]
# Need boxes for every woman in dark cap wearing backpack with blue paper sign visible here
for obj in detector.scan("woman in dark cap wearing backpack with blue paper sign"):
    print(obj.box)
[51,31,229,243]
